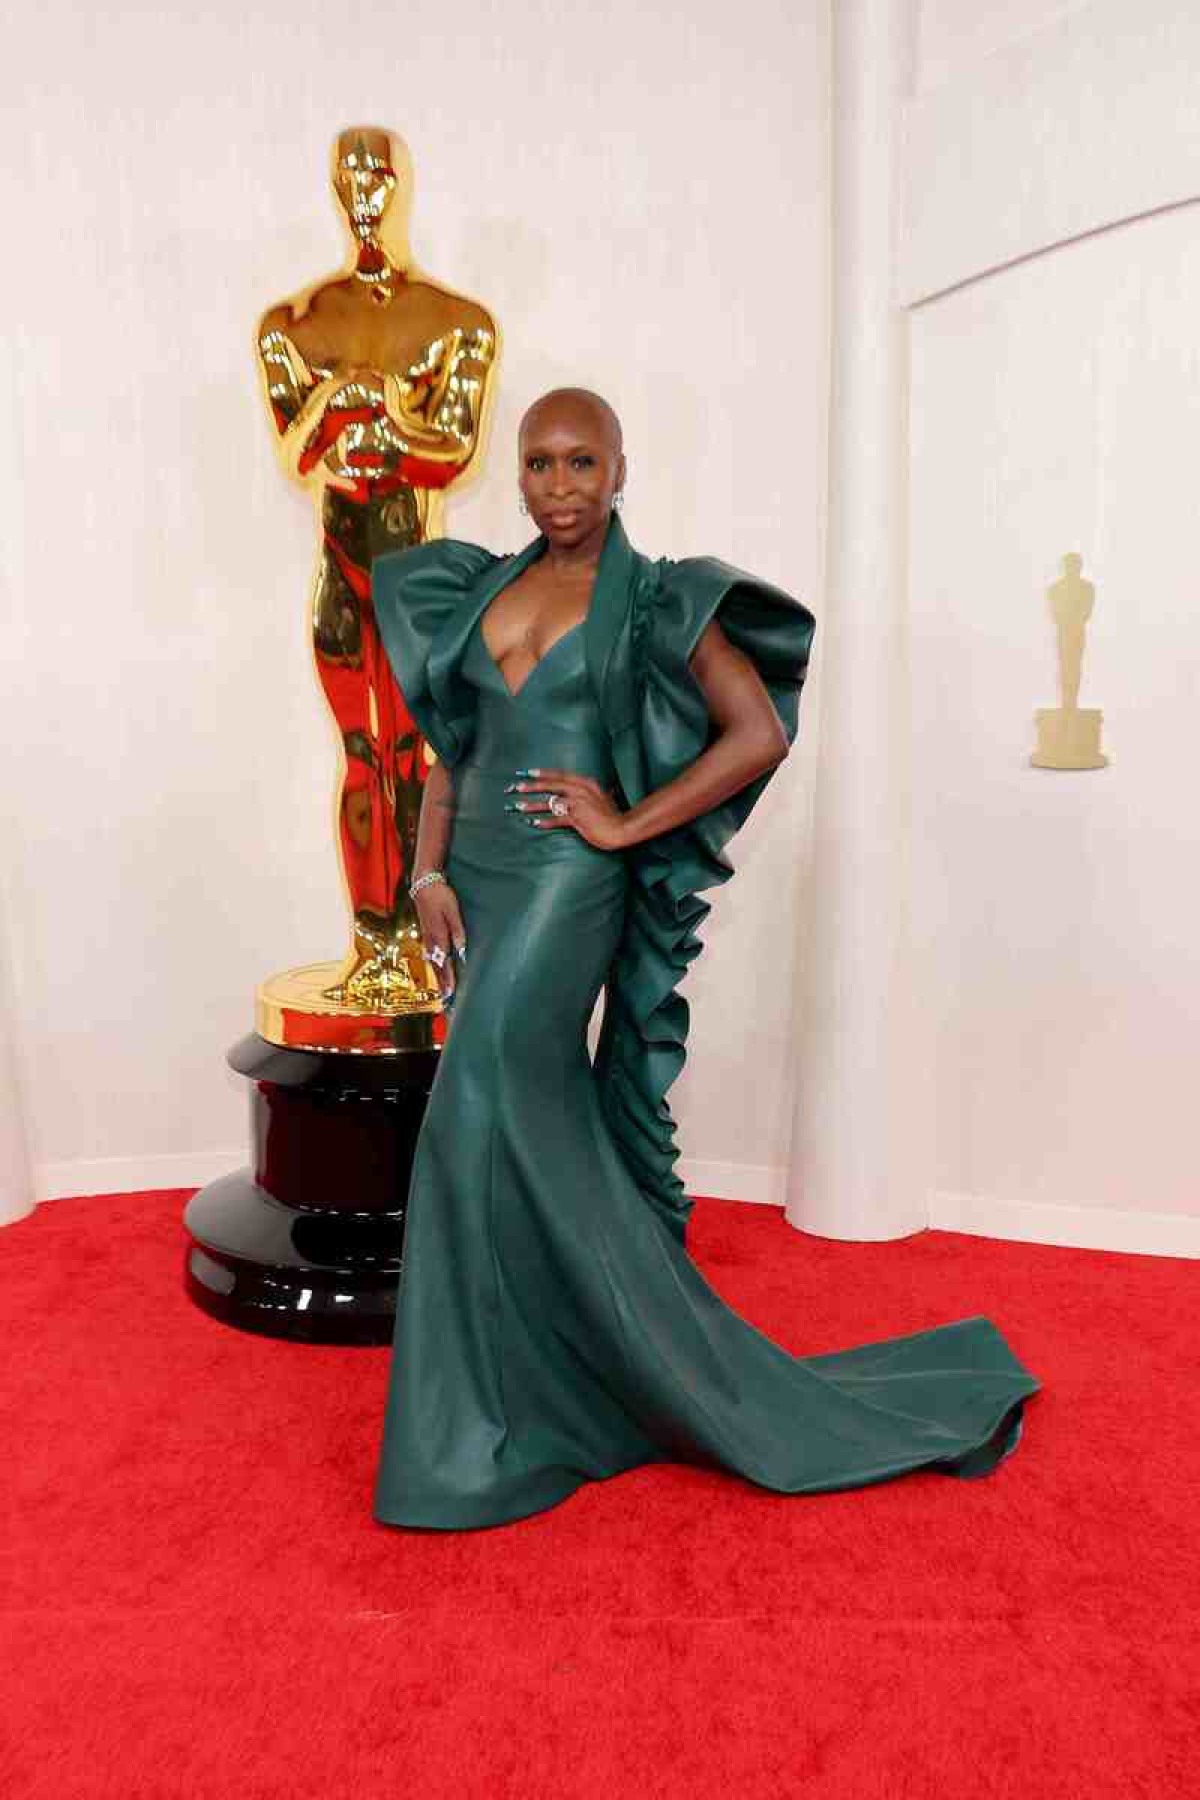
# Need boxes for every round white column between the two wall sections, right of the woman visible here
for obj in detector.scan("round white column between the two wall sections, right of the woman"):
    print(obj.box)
[786,0,930,1238]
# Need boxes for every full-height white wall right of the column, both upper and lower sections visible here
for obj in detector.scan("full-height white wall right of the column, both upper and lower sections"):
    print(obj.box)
[900,0,1200,1253]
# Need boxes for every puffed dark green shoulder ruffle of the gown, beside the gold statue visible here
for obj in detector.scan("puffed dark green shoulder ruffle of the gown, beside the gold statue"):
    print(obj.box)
[371,538,507,767]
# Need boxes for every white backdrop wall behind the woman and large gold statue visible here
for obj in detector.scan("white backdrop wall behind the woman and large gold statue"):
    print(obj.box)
[0,0,828,1197]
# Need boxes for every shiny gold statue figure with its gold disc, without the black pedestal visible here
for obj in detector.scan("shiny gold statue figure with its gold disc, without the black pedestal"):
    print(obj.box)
[257,126,497,1051]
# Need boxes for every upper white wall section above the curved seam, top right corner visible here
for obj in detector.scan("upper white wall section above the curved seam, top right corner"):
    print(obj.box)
[900,0,1200,304]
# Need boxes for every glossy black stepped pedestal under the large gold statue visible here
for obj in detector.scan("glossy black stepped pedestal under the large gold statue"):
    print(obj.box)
[184,1033,441,1345]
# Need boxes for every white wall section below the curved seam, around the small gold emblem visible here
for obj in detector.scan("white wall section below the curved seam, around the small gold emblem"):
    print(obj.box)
[910,189,1200,1249]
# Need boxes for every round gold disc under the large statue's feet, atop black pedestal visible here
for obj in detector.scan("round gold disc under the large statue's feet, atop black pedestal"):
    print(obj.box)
[254,963,446,1057]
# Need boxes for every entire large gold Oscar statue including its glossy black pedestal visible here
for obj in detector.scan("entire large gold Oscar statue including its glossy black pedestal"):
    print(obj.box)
[184,126,497,1345]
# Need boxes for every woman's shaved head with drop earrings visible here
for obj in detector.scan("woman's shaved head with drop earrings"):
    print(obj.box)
[518,387,624,549]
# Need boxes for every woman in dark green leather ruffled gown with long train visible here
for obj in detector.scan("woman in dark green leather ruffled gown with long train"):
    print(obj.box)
[372,389,1038,1528]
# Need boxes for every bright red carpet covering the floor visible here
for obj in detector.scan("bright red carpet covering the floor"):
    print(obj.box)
[0,1193,1200,1800]
